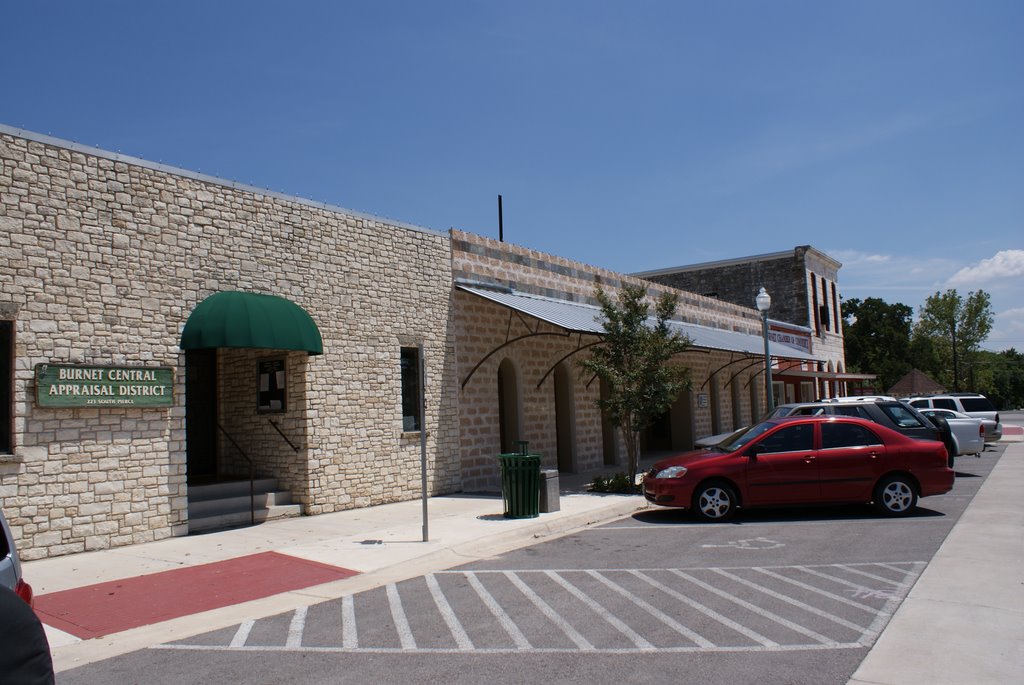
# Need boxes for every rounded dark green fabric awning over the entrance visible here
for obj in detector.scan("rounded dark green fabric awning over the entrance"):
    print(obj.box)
[180,291,324,354]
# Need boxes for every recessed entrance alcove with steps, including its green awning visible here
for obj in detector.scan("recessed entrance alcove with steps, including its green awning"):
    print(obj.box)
[179,291,324,532]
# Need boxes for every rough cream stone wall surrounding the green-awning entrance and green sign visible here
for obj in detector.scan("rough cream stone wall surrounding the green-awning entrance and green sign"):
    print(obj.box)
[0,129,461,559]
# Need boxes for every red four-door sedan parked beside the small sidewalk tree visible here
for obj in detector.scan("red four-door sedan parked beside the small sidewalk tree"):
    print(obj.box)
[643,416,953,521]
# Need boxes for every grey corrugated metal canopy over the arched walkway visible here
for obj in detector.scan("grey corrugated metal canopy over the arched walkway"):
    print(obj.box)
[456,283,819,361]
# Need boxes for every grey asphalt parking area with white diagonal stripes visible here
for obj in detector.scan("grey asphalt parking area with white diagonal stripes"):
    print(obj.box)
[58,447,1002,685]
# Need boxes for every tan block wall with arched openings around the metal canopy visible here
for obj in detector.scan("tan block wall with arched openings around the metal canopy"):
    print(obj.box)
[452,230,763,489]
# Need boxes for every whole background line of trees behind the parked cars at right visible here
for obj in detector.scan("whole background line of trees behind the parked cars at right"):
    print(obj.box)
[843,290,1024,410]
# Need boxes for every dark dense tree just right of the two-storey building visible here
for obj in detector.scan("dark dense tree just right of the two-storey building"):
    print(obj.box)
[843,297,926,390]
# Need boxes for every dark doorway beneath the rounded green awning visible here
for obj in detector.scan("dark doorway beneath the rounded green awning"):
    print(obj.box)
[185,349,217,483]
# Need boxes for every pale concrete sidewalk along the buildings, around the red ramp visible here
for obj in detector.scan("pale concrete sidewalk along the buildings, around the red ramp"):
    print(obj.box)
[24,460,649,672]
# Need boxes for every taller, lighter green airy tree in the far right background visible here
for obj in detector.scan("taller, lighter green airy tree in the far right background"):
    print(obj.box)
[913,289,994,391]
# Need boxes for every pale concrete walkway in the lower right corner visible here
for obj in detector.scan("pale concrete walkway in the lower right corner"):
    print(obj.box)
[850,435,1024,685]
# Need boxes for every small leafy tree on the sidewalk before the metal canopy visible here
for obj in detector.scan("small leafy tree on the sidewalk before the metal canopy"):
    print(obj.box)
[580,285,690,482]
